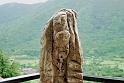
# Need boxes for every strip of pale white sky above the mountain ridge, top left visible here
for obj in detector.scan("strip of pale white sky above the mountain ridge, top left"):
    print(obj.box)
[0,0,47,5]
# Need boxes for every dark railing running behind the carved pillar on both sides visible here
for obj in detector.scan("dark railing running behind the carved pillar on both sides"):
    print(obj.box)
[0,73,124,83]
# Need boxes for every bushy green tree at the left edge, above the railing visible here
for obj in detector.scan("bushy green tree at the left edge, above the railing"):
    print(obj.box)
[0,50,19,78]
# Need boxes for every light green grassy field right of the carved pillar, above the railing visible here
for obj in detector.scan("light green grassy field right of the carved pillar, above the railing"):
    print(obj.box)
[83,57,124,77]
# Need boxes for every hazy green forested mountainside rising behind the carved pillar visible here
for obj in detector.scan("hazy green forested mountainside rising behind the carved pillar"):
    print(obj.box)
[0,0,124,57]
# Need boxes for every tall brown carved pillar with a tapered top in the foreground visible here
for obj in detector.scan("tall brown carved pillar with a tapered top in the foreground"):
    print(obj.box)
[40,9,83,83]
